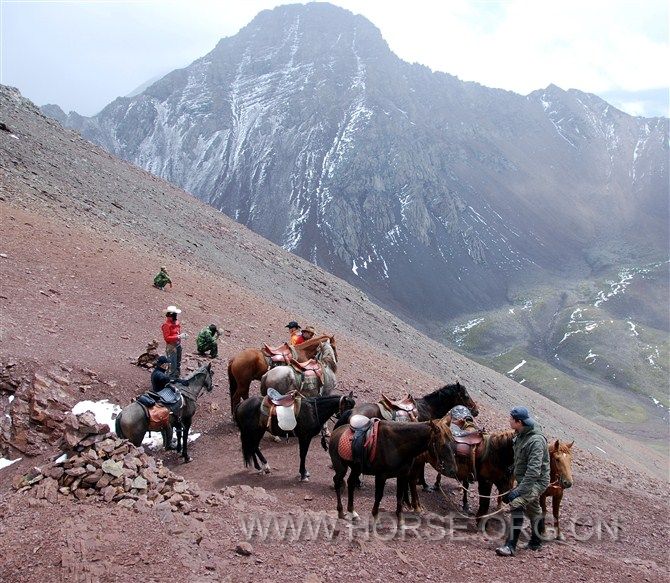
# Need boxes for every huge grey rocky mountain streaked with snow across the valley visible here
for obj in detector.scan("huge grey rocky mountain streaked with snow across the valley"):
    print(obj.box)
[44,3,668,325]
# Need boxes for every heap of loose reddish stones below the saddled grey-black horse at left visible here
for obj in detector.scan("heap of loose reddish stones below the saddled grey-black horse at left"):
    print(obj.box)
[14,412,199,513]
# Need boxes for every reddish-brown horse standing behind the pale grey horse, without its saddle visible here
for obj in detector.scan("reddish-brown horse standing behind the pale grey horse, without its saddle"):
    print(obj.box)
[228,334,337,418]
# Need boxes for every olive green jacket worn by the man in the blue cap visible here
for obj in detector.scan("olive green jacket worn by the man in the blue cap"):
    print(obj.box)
[514,424,549,497]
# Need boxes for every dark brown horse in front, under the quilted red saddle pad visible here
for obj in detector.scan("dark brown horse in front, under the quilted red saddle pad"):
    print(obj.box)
[329,415,456,525]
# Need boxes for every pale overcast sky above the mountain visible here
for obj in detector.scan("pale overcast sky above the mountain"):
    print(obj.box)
[0,0,670,116]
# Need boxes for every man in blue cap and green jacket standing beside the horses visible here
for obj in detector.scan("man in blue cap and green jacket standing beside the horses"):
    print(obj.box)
[496,407,549,557]
